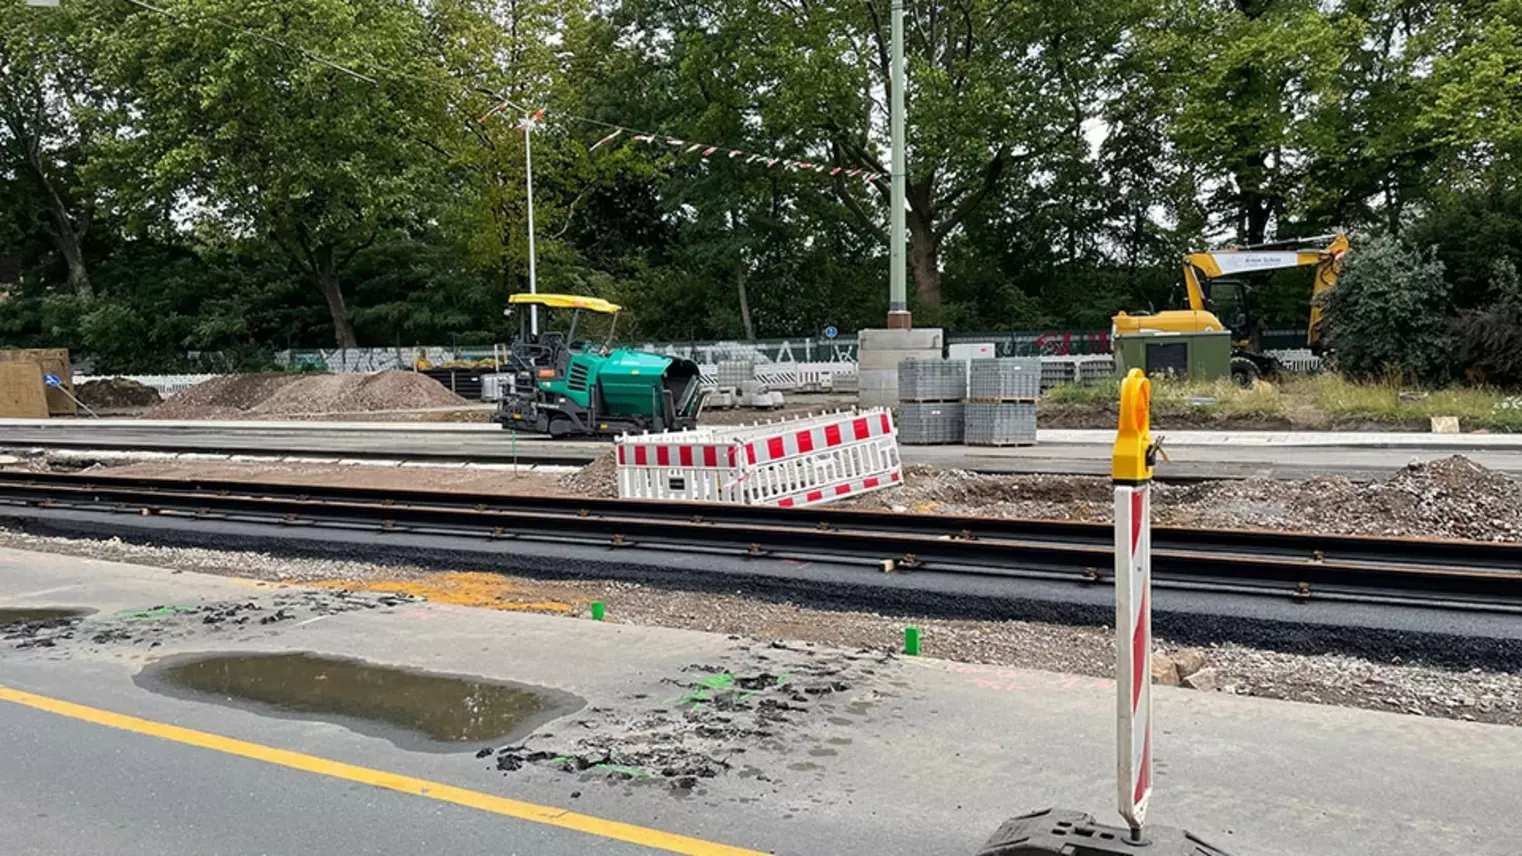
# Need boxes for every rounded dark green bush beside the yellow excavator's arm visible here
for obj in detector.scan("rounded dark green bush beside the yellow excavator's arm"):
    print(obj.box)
[1323,238,1454,382]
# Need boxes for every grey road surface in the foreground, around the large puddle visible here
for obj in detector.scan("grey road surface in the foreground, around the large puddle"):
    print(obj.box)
[0,551,1522,856]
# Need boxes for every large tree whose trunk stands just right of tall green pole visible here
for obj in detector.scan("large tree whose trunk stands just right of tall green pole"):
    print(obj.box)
[626,0,1132,311]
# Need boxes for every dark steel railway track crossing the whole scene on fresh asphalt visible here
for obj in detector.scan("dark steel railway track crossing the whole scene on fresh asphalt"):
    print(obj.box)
[0,472,1522,614]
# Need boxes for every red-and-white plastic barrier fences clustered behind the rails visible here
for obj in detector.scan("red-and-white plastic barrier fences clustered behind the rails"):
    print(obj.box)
[616,408,904,507]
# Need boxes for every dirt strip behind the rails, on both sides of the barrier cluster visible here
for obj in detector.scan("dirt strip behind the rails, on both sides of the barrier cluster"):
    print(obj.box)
[56,452,1522,542]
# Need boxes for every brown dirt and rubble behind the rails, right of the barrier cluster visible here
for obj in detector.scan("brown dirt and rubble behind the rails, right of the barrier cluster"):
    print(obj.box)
[842,455,1522,541]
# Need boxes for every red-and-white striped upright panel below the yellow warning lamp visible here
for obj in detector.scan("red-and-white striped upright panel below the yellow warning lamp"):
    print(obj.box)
[1116,481,1152,830]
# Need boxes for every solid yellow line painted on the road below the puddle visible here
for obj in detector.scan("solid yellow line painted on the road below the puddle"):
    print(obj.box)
[0,685,766,856]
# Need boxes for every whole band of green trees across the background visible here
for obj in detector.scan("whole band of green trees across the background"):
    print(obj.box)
[0,0,1522,376]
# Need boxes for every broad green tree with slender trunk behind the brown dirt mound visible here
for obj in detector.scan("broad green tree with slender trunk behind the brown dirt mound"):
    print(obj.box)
[105,0,450,347]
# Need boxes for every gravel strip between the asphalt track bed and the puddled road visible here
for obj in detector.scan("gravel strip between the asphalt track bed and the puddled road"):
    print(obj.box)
[0,530,1522,725]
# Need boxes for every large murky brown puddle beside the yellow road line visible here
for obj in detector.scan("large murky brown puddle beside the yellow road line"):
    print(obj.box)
[135,653,586,751]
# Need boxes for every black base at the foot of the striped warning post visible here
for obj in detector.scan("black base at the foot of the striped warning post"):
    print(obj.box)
[977,809,1227,856]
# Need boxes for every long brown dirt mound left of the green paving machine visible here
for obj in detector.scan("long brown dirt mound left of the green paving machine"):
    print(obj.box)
[148,372,470,419]
